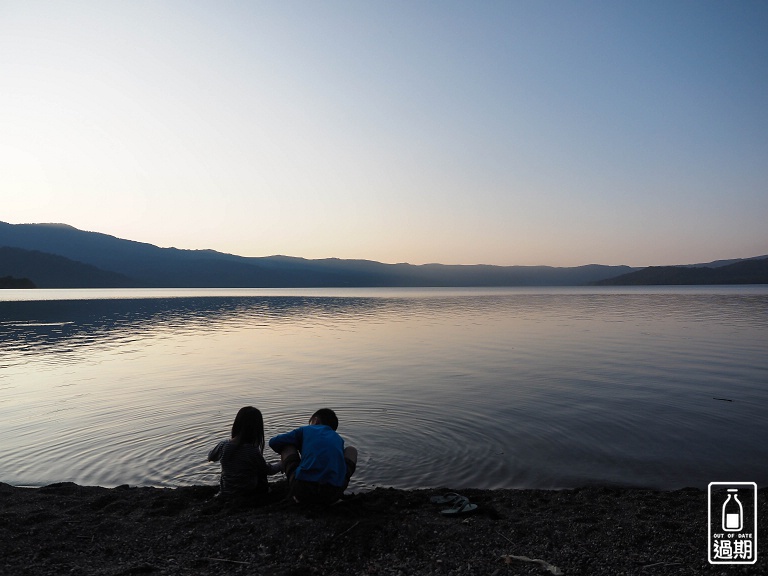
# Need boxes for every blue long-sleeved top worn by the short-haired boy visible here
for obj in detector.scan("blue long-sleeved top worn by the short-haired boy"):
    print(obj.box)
[269,424,347,487]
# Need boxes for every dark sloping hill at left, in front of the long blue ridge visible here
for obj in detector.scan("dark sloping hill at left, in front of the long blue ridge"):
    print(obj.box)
[0,246,135,288]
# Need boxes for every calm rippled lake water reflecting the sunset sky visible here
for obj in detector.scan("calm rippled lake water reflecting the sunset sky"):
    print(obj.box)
[0,286,768,489]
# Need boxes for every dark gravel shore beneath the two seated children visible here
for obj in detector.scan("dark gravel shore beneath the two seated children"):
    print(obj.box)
[0,483,768,576]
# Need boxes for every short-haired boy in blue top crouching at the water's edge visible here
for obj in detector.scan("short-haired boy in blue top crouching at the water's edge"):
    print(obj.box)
[269,408,357,504]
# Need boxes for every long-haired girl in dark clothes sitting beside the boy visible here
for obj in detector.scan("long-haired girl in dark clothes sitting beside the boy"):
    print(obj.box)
[208,406,281,497]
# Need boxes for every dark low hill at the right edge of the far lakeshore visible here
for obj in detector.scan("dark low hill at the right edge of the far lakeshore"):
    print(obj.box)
[594,257,768,286]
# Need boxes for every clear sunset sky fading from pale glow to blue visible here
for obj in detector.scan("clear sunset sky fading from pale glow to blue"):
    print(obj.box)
[0,0,768,266]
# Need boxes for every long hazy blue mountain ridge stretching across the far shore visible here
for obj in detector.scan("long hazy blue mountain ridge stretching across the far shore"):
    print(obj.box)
[0,222,635,288]
